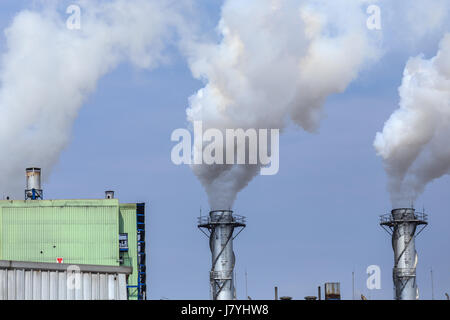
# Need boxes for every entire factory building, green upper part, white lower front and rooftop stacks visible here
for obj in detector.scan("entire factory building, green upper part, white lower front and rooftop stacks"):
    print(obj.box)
[0,168,146,300]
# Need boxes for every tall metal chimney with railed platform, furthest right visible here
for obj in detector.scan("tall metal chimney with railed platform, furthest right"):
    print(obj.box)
[380,208,428,300]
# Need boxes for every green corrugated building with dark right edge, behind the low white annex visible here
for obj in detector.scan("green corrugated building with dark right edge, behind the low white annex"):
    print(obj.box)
[0,182,146,299]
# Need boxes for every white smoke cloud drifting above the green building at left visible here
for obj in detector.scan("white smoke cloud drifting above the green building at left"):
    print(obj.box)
[0,0,185,195]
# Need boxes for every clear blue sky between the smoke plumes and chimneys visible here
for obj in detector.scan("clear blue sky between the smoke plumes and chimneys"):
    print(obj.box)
[0,0,450,299]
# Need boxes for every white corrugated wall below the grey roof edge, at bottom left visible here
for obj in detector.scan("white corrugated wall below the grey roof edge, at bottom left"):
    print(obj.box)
[0,268,127,300]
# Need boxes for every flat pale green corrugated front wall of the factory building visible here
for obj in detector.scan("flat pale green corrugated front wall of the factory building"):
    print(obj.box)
[0,199,119,266]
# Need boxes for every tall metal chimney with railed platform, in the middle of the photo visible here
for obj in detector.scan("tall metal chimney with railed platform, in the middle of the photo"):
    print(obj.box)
[198,210,246,300]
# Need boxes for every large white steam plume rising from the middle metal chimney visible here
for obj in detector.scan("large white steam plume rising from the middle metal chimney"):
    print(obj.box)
[187,0,379,209]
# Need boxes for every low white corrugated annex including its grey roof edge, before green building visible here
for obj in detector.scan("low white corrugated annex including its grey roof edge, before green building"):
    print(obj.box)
[0,260,132,300]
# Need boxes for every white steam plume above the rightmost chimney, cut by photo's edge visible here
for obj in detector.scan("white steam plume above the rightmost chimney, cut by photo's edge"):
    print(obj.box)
[374,34,450,206]
